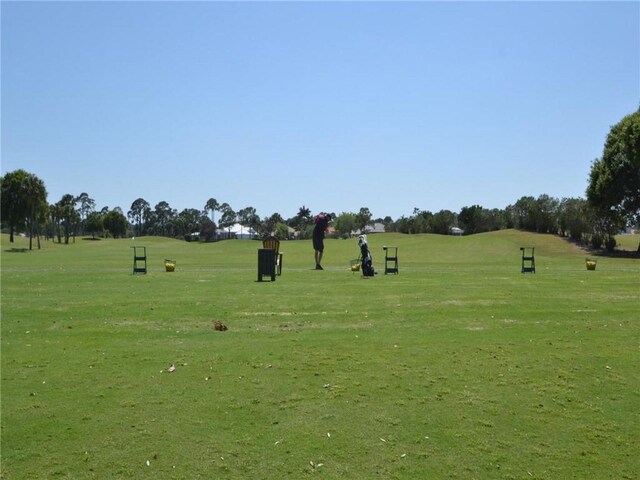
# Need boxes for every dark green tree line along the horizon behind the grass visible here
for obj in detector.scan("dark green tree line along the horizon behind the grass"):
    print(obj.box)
[0,109,640,253]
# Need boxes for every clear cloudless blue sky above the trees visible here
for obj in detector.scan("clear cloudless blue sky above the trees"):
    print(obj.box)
[1,1,640,219]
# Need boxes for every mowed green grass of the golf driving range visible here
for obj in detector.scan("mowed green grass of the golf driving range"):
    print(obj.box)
[1,231,640,479]
